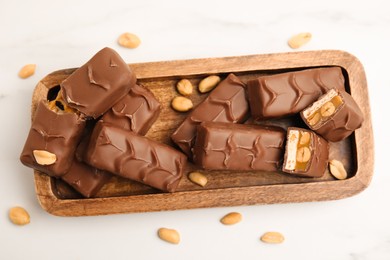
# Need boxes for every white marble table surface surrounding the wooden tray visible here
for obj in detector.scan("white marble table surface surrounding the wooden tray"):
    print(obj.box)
[0,0,390,260]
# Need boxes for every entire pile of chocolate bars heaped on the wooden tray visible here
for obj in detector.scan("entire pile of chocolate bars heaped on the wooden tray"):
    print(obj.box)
[20,48,363,197]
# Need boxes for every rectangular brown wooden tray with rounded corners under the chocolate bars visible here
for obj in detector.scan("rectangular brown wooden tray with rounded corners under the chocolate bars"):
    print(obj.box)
[32,50,374,216]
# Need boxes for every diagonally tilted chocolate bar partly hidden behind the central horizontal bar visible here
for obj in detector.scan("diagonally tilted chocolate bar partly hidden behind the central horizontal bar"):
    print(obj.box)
[171,74,249,157]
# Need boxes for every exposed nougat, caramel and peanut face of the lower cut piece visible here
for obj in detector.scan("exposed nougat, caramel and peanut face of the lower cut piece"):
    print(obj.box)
[284,129,312,171]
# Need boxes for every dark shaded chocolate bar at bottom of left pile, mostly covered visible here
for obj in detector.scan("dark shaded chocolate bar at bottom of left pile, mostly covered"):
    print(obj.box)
[61,160,111,198]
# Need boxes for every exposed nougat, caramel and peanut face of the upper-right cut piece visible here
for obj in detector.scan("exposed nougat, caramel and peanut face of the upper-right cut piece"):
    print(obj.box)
[302,89,344,129]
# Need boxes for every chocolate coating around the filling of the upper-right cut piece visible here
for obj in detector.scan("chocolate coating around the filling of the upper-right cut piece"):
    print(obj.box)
[300,91,364,142]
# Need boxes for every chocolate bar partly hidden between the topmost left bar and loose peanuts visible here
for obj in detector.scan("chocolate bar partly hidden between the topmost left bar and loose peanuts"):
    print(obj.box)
[102,85,161,135]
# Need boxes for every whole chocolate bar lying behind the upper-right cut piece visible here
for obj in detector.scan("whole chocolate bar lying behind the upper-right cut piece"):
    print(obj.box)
[248,67,345,120]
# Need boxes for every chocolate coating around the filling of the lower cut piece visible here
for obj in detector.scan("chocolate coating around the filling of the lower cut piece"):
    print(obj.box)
[282,127,329,178]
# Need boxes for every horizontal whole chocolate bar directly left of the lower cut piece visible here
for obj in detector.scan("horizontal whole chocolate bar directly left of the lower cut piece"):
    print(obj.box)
[193,122,286,171]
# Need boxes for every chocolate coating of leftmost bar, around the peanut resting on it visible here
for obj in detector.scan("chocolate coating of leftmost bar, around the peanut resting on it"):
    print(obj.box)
[20,101,85,177]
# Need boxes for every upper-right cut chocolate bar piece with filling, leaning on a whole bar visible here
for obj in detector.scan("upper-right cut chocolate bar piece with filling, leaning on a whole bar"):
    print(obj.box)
[300,89,363,142]
